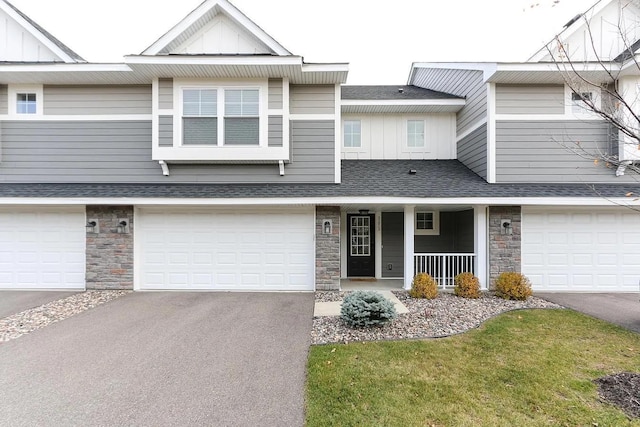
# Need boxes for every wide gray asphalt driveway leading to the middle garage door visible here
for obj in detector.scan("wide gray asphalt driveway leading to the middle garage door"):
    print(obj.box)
[0,292,314,426]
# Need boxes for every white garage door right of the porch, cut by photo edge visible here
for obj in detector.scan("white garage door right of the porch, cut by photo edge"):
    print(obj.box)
[522,208,640,292]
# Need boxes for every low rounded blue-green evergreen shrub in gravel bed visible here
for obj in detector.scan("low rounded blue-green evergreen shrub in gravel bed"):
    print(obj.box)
[340,291,398,328]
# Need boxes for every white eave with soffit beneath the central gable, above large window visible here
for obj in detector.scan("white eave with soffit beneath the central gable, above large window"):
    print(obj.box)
[125,55,349,84]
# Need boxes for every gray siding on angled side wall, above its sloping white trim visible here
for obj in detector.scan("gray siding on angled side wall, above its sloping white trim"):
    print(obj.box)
[412,68,487,135]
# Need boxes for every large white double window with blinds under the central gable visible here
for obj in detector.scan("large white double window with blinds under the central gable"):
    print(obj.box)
[182,88,260,146]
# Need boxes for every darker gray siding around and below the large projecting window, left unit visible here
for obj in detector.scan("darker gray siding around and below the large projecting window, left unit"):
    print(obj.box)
[0,120,335,184]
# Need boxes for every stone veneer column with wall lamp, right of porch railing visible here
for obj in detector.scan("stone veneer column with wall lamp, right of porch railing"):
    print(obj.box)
[489,206,522,289]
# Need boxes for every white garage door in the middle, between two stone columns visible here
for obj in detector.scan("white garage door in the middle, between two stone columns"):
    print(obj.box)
[136,209,315,291]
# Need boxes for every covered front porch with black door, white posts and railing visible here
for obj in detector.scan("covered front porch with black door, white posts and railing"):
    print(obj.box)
[340,205,488,290]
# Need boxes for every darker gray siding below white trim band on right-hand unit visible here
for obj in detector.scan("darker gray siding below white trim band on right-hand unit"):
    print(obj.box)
[496,120,633,183]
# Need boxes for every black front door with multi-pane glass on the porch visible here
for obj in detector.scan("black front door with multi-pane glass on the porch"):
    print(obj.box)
[347,214,376,277]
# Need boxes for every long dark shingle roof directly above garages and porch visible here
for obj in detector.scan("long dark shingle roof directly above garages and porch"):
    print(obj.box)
[0,160,640,202]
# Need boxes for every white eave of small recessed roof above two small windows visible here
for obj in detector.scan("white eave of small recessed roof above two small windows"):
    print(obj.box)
[341,98,466,113]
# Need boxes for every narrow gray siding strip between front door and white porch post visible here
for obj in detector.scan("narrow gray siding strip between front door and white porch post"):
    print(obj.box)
[382,212,404,277]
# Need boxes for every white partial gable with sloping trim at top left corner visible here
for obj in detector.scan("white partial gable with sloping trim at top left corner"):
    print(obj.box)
[0,0,86,63]
